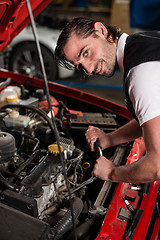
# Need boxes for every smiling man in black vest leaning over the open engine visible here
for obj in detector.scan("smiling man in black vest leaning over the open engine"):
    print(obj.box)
[55,18,160,183]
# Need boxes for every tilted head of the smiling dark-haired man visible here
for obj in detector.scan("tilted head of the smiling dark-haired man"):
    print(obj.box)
[55,18,120,77]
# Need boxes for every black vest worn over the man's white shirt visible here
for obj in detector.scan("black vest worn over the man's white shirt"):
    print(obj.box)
[123,31,160,121]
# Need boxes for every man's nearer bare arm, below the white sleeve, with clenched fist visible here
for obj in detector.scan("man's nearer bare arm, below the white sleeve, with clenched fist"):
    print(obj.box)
[93,116,160,183]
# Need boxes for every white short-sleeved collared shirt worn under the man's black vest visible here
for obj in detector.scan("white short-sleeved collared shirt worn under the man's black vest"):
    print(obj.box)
[117,34,160,125]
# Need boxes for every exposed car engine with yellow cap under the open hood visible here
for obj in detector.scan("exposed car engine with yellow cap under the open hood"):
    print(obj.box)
[0,83,131,240]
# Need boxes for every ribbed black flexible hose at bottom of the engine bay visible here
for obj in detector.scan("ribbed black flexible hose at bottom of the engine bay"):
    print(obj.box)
[51,197,83,240]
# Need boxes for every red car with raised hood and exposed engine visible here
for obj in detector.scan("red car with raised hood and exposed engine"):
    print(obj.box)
[0,0,160,240]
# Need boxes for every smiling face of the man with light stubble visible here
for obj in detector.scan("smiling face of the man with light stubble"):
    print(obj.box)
[64,22,117,77]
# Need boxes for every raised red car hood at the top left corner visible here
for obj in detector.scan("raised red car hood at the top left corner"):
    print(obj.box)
[0,0,51,51]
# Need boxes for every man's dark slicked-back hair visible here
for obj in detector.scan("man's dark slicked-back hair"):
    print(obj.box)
[55,17,121,69]
